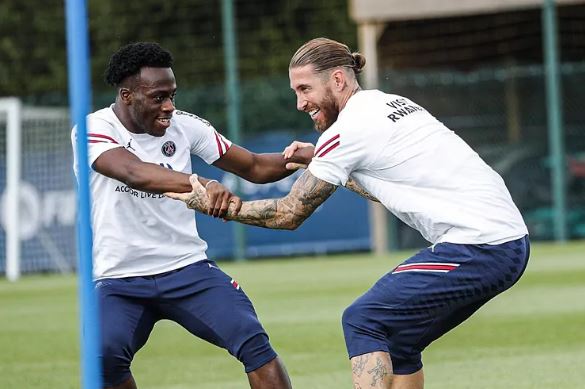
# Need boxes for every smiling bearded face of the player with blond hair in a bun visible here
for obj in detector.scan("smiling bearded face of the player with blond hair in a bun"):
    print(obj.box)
[289,65,340,132]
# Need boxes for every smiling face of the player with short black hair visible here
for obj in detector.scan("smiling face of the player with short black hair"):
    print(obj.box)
[120,67,177,137]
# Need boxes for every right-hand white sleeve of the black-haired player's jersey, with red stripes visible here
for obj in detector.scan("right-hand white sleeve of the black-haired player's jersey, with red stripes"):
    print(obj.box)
[176,111,232,165]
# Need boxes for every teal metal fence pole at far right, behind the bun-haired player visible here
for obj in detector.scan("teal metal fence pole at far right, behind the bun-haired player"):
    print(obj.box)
[542,0,567,242]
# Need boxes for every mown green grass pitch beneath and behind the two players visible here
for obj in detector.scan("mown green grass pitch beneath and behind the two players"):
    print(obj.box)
[0,242,585,389]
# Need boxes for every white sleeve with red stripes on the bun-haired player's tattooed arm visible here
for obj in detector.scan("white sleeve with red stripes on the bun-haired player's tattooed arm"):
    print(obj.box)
[309,123,364,186]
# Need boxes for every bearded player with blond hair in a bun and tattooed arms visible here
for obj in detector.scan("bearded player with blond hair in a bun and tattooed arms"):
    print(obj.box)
[168,38,529,389]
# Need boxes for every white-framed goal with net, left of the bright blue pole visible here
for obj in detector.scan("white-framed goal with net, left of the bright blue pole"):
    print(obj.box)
[0,97,76,281]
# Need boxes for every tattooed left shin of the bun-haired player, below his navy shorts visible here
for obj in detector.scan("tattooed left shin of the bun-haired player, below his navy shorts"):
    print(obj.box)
[351,351,392,389]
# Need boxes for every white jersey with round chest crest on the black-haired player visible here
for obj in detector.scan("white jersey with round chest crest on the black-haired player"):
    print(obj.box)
[71,106,231,279]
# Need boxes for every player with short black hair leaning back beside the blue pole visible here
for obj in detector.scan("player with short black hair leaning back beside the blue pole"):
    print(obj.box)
[72,42,312,389]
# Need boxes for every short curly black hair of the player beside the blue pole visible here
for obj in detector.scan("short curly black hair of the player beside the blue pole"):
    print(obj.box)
[104,42,173,86]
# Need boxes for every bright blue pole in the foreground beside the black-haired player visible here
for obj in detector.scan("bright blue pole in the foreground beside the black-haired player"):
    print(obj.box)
[65,0,102,389]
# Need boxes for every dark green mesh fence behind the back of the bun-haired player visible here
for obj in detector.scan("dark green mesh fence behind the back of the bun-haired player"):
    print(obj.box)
[382,63,585,247]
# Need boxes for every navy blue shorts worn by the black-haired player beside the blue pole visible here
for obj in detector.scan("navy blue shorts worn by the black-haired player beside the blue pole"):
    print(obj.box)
[95,260,276,387]
